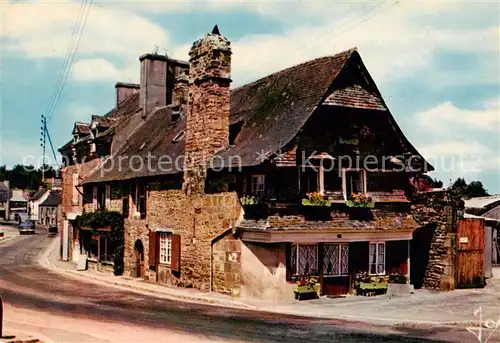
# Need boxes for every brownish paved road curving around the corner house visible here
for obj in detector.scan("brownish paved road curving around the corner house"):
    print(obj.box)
[0,233,484,342]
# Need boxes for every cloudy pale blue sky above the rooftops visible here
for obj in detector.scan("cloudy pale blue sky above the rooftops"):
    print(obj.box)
[0,0,500,194]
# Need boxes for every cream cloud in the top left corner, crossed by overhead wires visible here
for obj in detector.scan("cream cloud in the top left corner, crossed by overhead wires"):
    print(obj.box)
[0,2,169,58]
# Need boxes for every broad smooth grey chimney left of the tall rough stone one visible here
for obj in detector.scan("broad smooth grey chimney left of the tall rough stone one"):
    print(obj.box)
[139,54,168,117]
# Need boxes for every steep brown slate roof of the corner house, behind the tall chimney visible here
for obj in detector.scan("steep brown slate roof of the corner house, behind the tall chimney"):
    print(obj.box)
[83,49,432,183]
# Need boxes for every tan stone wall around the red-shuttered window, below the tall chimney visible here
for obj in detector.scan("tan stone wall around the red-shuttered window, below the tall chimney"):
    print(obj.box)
[124,190,242,293]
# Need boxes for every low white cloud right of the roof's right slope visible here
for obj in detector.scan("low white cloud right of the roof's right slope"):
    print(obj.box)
[410,99,500,187]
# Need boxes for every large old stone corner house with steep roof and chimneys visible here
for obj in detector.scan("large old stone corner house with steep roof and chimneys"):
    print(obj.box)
[60,27,454,298]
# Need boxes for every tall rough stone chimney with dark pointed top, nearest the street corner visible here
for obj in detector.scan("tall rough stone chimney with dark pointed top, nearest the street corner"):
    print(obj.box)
[183,25,231,195]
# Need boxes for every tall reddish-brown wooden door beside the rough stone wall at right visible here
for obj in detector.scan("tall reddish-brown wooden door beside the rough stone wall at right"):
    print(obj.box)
[455,219,485,288]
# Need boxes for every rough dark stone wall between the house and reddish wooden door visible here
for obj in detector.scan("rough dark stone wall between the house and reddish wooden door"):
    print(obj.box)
[412,192,463,291]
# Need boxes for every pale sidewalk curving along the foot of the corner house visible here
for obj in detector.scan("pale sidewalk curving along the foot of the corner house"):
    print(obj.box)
[40,240,500,326]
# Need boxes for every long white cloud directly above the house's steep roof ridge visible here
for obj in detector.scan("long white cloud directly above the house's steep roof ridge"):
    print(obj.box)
[173,2,498,85]
